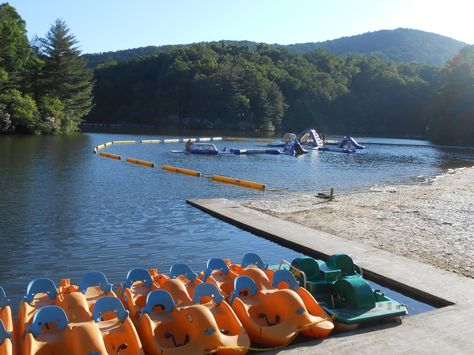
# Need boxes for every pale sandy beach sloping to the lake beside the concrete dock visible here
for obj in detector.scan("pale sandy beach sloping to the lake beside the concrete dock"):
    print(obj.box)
[245,167,474,278]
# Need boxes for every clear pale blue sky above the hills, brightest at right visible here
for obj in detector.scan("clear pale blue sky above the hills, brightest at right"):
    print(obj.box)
[4,0,474,53]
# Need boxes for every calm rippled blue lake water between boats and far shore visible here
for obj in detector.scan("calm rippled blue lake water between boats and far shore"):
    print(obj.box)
[0,133,474,307]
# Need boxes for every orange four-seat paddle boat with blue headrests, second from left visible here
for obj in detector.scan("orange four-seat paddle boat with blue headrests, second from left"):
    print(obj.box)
[17,272,143,355]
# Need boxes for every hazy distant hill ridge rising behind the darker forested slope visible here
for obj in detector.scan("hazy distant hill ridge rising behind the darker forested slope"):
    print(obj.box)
[83,28,466,68]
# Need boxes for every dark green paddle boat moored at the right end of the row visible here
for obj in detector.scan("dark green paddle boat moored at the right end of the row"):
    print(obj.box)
[280,254,408,328]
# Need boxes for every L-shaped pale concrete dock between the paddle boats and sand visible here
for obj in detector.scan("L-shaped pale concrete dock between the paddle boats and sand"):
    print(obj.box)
[187,199,474,354]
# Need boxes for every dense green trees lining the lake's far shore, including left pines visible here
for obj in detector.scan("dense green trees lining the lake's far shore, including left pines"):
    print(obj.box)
[0,4,474,146]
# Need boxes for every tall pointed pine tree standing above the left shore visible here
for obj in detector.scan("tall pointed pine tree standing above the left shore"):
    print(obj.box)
[39,19,93,132]
